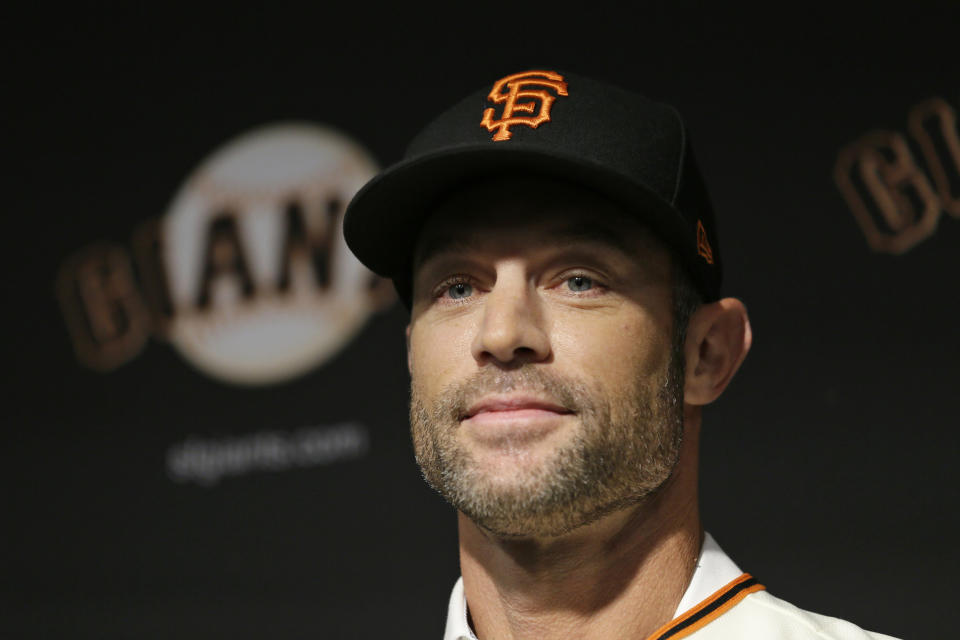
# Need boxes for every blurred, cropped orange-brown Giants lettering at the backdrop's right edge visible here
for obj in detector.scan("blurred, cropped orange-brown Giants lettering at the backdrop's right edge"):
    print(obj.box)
[833,98,960,254]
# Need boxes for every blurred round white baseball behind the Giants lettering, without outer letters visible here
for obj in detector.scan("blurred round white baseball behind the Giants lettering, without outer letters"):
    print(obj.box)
[161,124,389,385]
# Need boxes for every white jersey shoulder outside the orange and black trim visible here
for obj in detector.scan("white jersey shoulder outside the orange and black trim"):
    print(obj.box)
[684,590,894,640]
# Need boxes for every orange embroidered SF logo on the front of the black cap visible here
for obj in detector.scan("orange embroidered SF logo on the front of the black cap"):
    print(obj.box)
[480,71,567,140]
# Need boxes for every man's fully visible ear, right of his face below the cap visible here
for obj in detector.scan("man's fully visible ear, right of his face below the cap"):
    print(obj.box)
[683,298,753,405]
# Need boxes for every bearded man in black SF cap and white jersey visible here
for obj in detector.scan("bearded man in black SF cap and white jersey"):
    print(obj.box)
[344,70,885,640]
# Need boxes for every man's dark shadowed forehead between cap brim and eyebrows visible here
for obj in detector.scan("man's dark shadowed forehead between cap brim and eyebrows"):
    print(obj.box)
[415,177,662,266]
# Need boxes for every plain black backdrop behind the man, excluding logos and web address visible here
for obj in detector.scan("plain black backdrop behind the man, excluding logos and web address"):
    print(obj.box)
[0,3,960,638]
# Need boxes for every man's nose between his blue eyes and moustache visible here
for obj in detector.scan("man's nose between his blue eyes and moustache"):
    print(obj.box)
[471,265,550,365]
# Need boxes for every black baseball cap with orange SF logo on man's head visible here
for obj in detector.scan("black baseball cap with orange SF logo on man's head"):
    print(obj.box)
[343,70,722,308]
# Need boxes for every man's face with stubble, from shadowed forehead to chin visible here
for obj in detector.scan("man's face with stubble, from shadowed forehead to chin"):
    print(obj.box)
[409,180,683,536]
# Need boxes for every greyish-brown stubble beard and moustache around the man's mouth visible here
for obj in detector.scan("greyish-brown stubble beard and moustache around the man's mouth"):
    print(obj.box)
[410,353,684,537]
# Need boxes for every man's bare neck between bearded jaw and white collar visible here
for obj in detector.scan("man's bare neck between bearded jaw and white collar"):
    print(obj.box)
[459,415,703,640]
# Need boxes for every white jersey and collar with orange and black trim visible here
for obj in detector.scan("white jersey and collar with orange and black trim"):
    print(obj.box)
[443,534,895,640]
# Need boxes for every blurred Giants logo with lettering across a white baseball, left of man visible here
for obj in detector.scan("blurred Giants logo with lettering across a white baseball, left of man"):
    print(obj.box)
[57,124,393,385]
